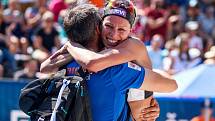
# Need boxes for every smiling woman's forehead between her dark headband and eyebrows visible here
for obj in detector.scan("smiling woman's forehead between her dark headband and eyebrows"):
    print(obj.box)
[103,15,130,27]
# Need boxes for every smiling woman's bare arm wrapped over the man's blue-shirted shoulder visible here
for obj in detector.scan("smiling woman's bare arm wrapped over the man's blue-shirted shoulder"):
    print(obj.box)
[67,38,151,72]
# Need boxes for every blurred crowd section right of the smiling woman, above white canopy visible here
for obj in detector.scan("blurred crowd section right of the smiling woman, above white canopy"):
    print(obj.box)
[133,0,215,75]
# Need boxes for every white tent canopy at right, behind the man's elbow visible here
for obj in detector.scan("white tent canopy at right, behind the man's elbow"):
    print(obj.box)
[155,64,215,97]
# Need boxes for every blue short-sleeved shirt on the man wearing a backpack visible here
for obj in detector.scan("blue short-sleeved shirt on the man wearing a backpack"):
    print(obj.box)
[66,61,145,121]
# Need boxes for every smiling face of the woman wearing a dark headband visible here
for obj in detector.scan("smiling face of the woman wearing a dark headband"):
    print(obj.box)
[102,15,131,48]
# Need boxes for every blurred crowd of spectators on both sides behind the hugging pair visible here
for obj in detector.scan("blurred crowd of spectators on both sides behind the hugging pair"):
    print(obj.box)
[0,0,215,80]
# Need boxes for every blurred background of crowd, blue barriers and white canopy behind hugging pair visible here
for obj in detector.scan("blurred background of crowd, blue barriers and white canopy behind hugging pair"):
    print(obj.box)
[0,0,215,121]
